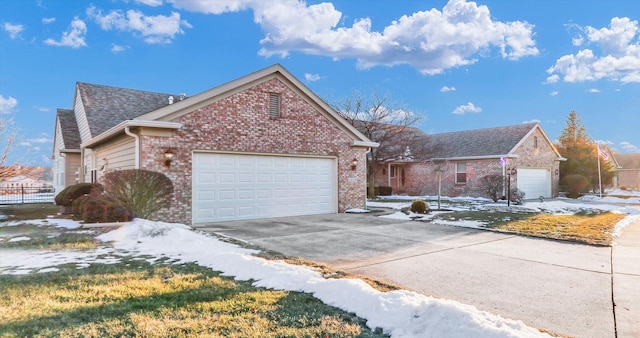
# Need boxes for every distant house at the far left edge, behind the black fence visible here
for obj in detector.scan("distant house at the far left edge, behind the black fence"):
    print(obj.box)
[0,165,52,188]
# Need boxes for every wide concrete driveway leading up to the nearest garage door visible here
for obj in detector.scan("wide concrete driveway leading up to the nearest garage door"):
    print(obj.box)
[201,214,640,337]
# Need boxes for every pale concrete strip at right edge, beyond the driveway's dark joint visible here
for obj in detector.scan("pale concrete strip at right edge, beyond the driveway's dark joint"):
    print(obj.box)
[611,221,640,338]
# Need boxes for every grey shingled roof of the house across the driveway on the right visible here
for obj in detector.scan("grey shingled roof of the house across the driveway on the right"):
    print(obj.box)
[426,123,539,159]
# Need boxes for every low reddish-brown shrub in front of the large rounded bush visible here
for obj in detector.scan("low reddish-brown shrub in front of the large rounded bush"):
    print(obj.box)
[73,195,133,223]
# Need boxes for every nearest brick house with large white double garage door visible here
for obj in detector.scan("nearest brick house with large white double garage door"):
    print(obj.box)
[53,64,377,225]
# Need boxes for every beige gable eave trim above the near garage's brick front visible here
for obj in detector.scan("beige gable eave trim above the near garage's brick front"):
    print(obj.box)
[135,64,378,147]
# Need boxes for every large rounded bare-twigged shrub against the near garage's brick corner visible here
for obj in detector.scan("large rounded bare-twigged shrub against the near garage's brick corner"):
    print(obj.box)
[103,169,173,218]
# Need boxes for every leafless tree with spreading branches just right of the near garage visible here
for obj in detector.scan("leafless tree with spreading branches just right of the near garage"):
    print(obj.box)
[333,93,425,197]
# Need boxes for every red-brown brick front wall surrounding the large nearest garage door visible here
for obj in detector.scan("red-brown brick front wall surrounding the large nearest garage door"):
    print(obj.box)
[136,78,366,224]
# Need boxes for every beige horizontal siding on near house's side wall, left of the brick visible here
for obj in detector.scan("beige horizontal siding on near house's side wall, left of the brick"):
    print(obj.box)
[95,135,135,179]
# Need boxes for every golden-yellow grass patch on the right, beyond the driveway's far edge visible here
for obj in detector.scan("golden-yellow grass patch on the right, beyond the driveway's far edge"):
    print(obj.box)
[494,212,626,246]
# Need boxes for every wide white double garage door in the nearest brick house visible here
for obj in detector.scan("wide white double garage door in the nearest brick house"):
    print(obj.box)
[193,153,338,224]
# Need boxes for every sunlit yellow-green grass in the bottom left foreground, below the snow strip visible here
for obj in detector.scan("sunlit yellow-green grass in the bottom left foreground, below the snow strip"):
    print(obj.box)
[0,258,385,337]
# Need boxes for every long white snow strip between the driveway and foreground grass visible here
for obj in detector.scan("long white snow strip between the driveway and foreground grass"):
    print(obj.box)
[0,219,548,337]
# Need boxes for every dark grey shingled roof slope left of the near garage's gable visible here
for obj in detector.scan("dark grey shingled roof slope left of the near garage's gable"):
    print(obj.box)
[77,82,180,137]
